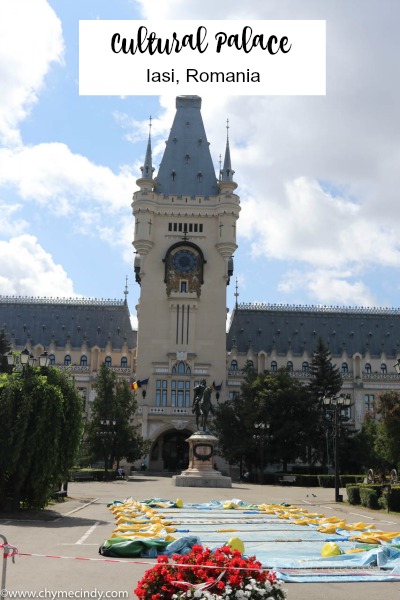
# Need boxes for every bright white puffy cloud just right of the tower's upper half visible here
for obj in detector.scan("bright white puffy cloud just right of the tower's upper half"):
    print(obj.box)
[240,177,400,268]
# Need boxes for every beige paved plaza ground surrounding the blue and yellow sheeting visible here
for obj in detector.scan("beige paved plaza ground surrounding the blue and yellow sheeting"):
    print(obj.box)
[0,473,400,600]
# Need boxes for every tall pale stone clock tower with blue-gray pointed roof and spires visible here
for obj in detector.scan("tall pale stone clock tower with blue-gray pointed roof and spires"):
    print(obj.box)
[132,96,240,470]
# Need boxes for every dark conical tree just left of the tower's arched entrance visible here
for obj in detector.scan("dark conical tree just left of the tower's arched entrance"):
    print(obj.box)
[86,364,149,473]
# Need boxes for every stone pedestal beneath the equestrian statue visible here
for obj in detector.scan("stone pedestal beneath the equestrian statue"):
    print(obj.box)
[172,431,232,488]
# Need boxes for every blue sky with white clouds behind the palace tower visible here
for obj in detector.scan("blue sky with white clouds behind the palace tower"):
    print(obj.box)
[0,0,400,330]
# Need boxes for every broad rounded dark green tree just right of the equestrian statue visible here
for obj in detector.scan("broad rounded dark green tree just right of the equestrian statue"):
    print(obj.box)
[214,369,319,471]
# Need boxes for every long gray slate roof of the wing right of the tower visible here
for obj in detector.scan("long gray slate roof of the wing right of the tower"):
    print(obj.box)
[227,304,400,358]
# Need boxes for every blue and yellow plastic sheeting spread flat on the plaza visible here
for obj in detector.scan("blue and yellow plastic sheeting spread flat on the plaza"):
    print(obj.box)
[99,498,400,582]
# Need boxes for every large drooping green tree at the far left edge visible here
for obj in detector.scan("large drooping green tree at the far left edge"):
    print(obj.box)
[0,366,82,509]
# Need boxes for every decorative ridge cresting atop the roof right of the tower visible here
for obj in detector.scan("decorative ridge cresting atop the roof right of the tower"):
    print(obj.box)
[236,302,400,315]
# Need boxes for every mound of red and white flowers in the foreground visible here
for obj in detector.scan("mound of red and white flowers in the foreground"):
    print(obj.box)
[135,545,286,600]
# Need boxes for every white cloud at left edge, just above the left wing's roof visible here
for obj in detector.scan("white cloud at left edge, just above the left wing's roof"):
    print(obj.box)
[0,234,76,297]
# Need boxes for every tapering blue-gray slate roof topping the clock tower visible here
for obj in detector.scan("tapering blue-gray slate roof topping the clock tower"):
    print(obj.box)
[154,96,218,197]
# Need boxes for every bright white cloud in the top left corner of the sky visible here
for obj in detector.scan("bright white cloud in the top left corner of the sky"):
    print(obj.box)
[0,0,64,145]
